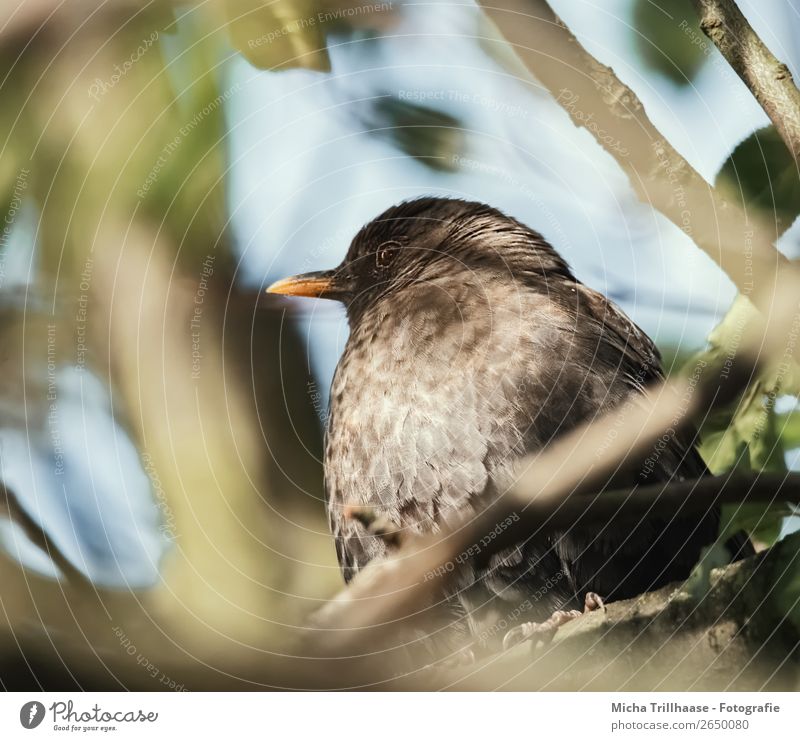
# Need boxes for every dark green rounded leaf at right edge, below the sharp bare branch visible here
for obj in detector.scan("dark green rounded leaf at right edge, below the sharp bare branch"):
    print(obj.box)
[715,126,800,232]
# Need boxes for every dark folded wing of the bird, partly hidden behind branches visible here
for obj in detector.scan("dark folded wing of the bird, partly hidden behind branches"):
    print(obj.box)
[528,284,719,598]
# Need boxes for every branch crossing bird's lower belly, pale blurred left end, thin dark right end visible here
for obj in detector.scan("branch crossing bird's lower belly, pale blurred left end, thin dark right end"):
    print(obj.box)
[312,468,800,656]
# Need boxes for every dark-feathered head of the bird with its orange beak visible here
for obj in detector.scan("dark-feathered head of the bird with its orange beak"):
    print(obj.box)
[267,198,571,316]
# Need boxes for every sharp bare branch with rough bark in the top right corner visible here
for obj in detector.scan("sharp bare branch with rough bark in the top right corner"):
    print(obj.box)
[692,0,800,163]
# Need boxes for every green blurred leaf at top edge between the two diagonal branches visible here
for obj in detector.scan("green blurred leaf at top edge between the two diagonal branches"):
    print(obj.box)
[633,0,711,85]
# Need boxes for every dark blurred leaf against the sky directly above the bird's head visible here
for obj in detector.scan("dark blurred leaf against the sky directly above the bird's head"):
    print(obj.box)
[368,96,465,171]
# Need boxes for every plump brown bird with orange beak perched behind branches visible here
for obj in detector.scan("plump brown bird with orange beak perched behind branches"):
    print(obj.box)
[267,196,746,651]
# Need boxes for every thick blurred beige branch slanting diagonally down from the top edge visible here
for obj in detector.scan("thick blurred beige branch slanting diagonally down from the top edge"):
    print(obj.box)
[481,0,785,300]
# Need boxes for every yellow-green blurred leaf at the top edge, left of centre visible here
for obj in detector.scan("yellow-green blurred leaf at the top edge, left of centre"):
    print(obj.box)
[225,0,331,72]
